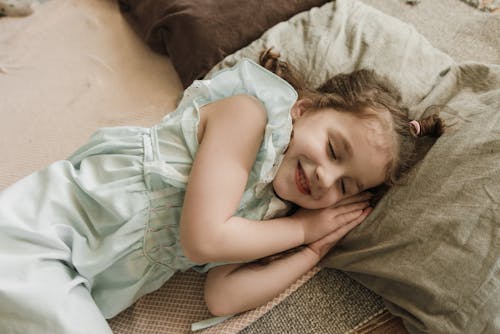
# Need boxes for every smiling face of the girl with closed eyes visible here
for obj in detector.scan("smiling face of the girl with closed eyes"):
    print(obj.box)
[273,100,393,209]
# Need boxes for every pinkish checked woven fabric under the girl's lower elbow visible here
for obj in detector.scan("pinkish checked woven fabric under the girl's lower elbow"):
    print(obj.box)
[109,267,319,334]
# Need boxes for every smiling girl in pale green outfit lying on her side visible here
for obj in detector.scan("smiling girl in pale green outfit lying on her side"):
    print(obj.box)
[0,52,442,333]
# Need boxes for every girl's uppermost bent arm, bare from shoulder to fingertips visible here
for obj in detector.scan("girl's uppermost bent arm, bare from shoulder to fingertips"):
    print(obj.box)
[180,95,372,263]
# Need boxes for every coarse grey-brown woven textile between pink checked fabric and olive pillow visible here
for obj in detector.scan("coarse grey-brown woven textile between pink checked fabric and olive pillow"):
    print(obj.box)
[241,269,384,334]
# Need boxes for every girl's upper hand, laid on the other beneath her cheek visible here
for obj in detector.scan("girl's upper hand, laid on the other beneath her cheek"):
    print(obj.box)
[292,192,372,244]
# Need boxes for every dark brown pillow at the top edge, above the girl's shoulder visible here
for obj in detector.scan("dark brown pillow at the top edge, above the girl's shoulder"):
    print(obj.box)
[119,0,327,87]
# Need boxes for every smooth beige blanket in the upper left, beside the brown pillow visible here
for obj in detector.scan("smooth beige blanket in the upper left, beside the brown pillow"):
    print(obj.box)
[0,0,181,189]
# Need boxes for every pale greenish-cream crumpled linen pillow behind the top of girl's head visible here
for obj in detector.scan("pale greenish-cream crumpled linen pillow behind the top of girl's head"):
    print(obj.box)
[207,1,453,110]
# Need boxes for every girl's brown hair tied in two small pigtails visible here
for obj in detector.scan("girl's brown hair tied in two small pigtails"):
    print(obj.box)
[260,49,444,186]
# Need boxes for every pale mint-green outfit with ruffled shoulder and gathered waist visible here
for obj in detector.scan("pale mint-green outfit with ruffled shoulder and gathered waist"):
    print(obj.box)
[0,60,297,334]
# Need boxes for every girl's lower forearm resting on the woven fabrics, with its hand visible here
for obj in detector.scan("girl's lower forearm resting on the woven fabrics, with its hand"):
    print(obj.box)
[205,208,371,316]
